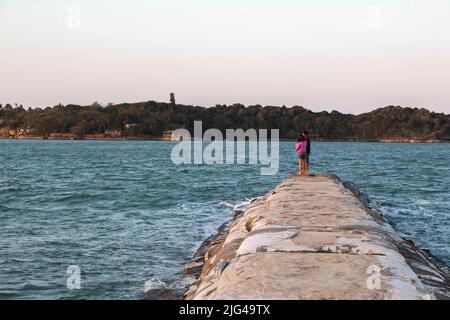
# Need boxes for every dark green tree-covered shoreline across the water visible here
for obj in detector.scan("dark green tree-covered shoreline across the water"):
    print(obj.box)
[0,101,450,141]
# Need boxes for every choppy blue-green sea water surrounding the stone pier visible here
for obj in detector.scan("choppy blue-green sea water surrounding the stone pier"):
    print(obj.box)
[0,140,450,299]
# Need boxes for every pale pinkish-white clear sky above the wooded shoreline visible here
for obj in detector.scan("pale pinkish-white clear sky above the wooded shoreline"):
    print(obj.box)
[0,0,450,114]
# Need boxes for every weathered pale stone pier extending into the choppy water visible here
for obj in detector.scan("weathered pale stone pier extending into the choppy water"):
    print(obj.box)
[183,174,450,300]
